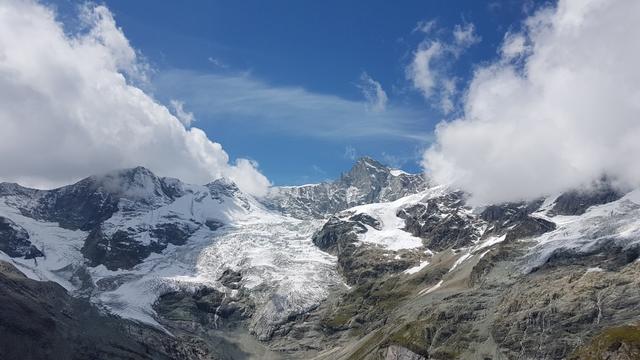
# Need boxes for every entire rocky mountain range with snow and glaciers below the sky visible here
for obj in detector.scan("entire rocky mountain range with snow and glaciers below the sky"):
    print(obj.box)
[0,158,640,360]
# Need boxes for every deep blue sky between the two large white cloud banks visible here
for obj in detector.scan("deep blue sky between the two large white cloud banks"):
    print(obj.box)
[50,0,536,185]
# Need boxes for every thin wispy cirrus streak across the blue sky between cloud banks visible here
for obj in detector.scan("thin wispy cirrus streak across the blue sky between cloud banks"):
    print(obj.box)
[152,69,431,141]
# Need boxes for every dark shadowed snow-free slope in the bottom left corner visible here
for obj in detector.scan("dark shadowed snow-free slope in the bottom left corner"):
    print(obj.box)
[0,262,208,360]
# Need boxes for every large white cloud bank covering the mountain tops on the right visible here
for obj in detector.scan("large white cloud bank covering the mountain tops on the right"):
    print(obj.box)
[423,0,640,202]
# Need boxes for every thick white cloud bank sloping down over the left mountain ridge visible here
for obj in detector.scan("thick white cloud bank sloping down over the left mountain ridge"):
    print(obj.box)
[0,0,270,195]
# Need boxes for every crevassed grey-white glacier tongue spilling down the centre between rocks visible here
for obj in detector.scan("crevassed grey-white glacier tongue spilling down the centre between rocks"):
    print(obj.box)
[175,213,343,340]
